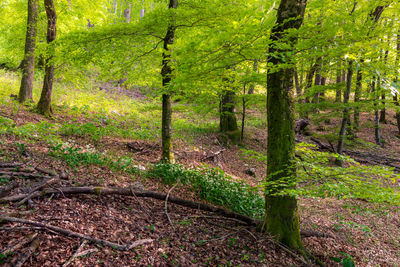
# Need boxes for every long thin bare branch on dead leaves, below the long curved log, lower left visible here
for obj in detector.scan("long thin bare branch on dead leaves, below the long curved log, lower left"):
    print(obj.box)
[0,216,153,251]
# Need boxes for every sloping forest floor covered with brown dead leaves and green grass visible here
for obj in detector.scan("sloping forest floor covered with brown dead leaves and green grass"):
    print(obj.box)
[0,71,400,266]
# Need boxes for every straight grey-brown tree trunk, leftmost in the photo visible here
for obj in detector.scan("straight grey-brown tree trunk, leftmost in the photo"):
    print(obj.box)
[18,0,38,103]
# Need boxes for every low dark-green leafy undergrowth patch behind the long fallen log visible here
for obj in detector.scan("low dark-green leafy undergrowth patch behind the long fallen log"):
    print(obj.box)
[148,164,264,218]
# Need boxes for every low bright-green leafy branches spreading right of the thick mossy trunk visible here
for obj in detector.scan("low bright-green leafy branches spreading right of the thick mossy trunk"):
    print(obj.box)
[242,143,400,205]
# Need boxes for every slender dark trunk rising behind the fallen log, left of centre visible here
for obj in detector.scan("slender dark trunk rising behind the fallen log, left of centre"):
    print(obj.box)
[161,0,178,163]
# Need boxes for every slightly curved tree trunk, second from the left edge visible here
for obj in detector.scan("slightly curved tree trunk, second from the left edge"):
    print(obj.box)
[37,0,57,116]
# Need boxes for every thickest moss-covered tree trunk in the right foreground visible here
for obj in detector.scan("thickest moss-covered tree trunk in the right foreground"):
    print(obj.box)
[265,0,307,252]
